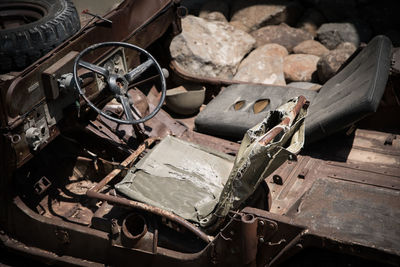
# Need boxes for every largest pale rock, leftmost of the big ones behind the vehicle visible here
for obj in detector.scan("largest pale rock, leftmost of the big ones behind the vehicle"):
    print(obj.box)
[170,15,255,79]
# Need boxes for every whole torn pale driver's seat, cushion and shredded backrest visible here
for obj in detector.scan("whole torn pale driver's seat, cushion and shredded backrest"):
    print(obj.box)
[115,98,306,227]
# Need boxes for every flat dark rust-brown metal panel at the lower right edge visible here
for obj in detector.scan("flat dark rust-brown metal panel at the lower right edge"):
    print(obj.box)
[287,178,400,255]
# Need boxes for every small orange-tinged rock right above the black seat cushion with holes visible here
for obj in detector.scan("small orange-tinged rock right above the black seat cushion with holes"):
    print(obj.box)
[283,54,319,82]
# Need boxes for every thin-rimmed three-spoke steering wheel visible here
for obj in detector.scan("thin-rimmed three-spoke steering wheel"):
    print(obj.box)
[72,42,167,124]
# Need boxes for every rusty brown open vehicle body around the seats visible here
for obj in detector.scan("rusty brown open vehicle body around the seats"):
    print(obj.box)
[0,0,400,266]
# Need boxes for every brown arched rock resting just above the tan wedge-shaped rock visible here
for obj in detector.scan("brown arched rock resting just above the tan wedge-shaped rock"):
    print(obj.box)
[251,23,313,52]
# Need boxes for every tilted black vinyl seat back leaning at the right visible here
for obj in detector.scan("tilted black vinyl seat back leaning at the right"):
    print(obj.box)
[306,36,392,143]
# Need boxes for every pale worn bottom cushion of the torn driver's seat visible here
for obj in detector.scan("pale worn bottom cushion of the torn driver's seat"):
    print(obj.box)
[116,136,234,224]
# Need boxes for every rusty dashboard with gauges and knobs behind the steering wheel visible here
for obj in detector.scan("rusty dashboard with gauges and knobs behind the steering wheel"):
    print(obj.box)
[5,47,128,166]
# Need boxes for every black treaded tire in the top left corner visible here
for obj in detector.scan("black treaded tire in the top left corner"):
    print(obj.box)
[0,0,80,73]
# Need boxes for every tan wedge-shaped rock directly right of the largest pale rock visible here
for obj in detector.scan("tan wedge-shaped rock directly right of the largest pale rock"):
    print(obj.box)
[233,44,288,85]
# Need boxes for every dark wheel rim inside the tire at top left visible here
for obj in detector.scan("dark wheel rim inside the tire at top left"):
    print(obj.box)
[0,3,48,30]
